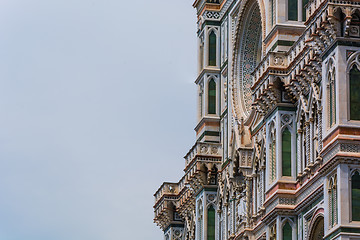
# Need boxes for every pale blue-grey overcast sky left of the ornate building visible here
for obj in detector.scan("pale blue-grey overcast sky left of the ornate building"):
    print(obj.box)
[0,0,197,240]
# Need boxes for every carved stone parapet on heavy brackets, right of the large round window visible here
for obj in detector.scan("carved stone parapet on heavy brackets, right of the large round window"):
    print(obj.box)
[252,0,340,115]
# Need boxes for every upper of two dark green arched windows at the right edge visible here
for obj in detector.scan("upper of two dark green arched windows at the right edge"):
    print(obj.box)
[349,65,360,120]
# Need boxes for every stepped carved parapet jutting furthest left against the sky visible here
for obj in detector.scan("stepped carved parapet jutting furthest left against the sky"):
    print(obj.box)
[154,142,222,230]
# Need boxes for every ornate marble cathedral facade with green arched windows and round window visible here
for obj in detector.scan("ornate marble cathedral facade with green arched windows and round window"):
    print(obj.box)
[154,0,360,240]
